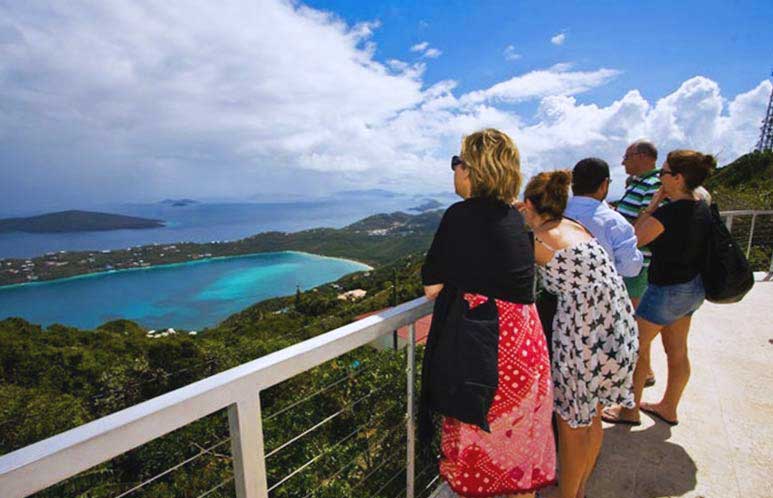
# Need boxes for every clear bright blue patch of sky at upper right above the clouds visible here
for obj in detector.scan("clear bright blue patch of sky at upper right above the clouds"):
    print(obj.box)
[306,1,773,105]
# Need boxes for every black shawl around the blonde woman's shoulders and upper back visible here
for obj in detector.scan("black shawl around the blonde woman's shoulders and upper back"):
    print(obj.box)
[421,198,534,304]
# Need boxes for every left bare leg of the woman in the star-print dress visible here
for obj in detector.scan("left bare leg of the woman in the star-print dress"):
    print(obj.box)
[556,417,591,498]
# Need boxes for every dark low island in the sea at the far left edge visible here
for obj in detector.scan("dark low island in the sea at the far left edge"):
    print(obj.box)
[0,210,164,233]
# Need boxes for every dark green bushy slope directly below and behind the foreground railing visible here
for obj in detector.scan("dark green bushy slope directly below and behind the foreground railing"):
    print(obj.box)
[0,254,434,498]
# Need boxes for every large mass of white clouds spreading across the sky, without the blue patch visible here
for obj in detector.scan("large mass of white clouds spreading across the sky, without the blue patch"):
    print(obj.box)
[0,0,770,210]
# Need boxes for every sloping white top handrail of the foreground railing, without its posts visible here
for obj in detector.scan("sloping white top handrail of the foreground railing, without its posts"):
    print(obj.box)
[0,297,432,496]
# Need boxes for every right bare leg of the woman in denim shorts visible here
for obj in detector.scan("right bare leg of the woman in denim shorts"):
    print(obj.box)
[647,316,691,421]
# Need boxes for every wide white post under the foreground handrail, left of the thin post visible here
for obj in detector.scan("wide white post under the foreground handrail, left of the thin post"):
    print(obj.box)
[228,392,268,498]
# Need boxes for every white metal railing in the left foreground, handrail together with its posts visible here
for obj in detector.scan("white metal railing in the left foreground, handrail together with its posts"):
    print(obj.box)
[0,297,432,498]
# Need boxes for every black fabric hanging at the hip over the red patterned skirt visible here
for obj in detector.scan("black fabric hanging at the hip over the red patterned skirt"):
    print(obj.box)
[422,291,499,432]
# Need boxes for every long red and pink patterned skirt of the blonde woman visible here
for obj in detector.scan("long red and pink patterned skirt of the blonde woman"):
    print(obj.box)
[440,294,556,497]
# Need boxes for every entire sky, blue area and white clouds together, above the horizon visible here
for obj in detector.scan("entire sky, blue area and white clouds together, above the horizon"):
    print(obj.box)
[0,0,773,212]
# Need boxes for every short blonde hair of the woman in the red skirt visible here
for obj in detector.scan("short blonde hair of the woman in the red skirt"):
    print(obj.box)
[461,128,521,204]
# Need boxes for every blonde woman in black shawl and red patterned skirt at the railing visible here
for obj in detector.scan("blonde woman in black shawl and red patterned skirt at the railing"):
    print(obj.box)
[420,129,555,497]
